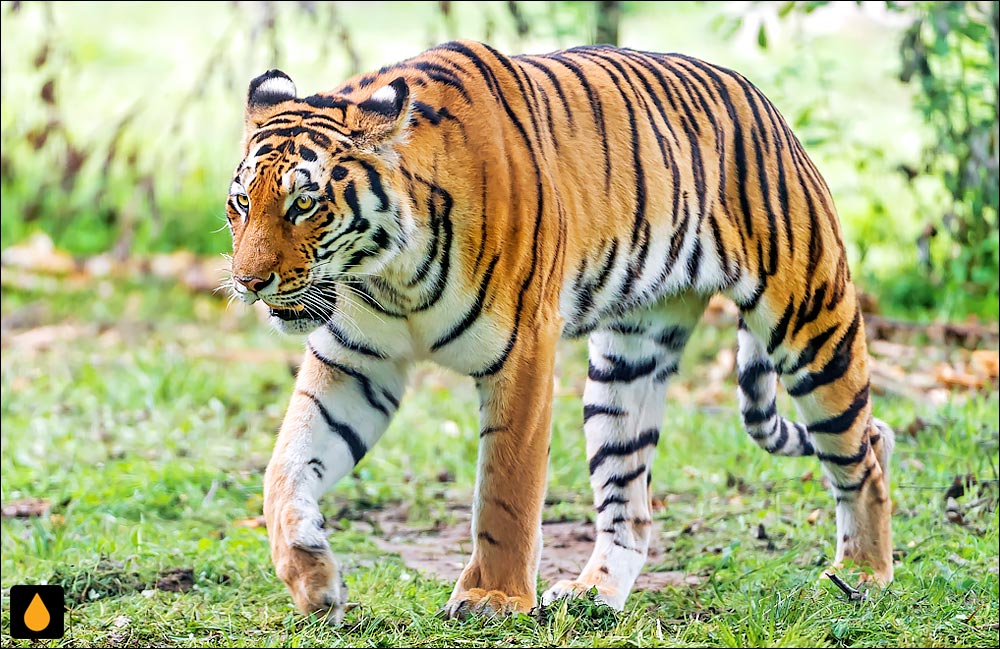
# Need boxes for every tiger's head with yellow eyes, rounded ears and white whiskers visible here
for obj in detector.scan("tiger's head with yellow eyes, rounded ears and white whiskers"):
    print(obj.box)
[226,70,413,333]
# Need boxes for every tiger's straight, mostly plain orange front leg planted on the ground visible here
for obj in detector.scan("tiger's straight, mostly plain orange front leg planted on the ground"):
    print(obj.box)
[443,314,560,618]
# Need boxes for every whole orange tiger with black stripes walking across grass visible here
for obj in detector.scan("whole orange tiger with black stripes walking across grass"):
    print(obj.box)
[226,41,894,624]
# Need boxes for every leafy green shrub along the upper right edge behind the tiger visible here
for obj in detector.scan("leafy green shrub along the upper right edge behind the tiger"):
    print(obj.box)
[893,1,1000,312]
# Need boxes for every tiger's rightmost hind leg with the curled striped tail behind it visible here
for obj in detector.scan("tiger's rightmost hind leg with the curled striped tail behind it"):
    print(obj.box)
[737,301,894,585]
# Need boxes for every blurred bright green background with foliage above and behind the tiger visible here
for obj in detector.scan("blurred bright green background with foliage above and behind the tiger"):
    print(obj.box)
[0,1,1000,320]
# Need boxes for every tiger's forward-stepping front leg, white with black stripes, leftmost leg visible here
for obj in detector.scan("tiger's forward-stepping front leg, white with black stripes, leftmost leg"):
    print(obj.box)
[264,333,403,624]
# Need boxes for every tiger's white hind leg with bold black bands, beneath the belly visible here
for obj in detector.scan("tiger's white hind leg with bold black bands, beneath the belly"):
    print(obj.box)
[542,296,706,610]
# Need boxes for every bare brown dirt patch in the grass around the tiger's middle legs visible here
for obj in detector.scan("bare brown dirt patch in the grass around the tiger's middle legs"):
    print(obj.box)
[368,505,704,590]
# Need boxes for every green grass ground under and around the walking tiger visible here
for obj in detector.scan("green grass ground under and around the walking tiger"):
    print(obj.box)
[0,278,1000,647]
